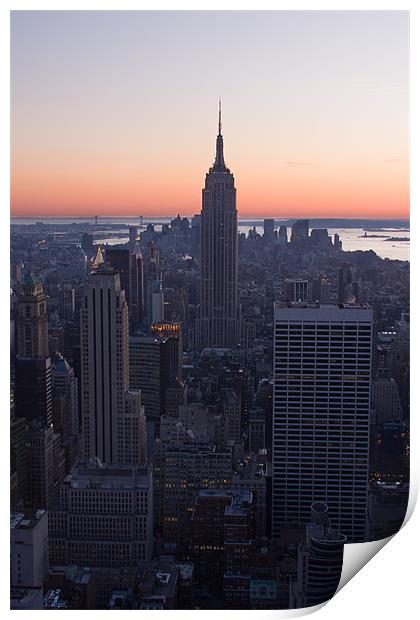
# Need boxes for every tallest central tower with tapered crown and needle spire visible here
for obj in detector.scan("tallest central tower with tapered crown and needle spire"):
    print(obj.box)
[197,101,240,348]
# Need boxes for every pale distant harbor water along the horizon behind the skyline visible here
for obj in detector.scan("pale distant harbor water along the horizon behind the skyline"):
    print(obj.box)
[11,217,410,260]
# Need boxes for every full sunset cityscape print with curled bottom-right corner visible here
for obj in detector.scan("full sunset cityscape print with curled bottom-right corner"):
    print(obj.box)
[9,11,411,611]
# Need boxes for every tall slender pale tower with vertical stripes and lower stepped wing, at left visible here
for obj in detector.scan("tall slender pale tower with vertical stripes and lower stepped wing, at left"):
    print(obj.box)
[80,265,143,464]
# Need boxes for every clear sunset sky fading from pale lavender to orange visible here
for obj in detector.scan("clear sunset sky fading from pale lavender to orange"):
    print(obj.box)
[11,11,409,218]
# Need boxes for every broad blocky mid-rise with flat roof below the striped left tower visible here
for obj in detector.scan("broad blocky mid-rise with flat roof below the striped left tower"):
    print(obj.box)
[48,459,153,608]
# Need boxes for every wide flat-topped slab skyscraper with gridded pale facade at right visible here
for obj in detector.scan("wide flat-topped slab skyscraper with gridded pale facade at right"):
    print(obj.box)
[272,304,373,542]
